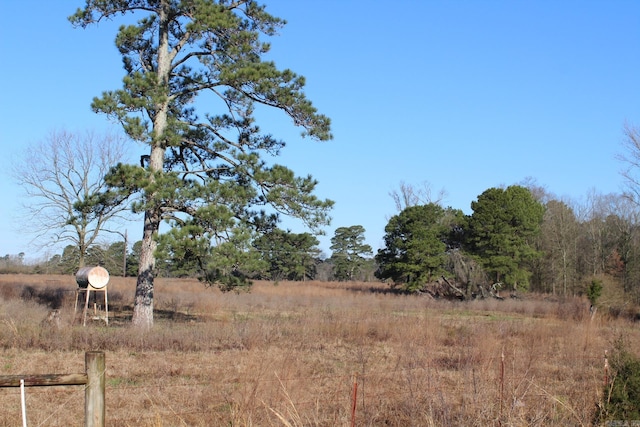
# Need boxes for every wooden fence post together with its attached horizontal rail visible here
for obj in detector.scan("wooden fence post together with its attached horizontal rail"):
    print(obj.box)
[0,351,105,427]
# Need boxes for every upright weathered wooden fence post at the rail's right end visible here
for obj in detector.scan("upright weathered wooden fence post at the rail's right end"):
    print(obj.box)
[84,351,105,427]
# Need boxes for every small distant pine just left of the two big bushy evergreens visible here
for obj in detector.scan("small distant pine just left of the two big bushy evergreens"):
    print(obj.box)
[330,225,373,281]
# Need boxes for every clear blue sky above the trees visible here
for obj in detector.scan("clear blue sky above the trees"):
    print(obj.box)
[0,0,640,257]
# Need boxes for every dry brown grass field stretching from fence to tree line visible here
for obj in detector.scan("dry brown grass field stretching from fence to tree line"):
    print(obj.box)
[0,275,640,427]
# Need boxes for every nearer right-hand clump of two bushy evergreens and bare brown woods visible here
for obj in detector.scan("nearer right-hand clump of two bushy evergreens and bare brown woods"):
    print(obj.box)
[376,183,640,302]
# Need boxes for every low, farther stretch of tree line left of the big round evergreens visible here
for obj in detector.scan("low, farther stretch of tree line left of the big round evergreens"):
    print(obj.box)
[7,226,375,282]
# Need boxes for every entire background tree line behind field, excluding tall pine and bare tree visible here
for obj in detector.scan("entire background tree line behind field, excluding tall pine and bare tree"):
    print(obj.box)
[8,184,640,303]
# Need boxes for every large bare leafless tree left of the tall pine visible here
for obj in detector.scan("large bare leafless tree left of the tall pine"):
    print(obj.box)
[12,131,128,268]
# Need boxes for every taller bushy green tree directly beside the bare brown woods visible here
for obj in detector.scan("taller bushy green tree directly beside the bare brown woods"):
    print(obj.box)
[467,185,544,289]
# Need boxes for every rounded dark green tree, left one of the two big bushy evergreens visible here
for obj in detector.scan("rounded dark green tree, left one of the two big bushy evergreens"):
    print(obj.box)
[375,203,450,291]
